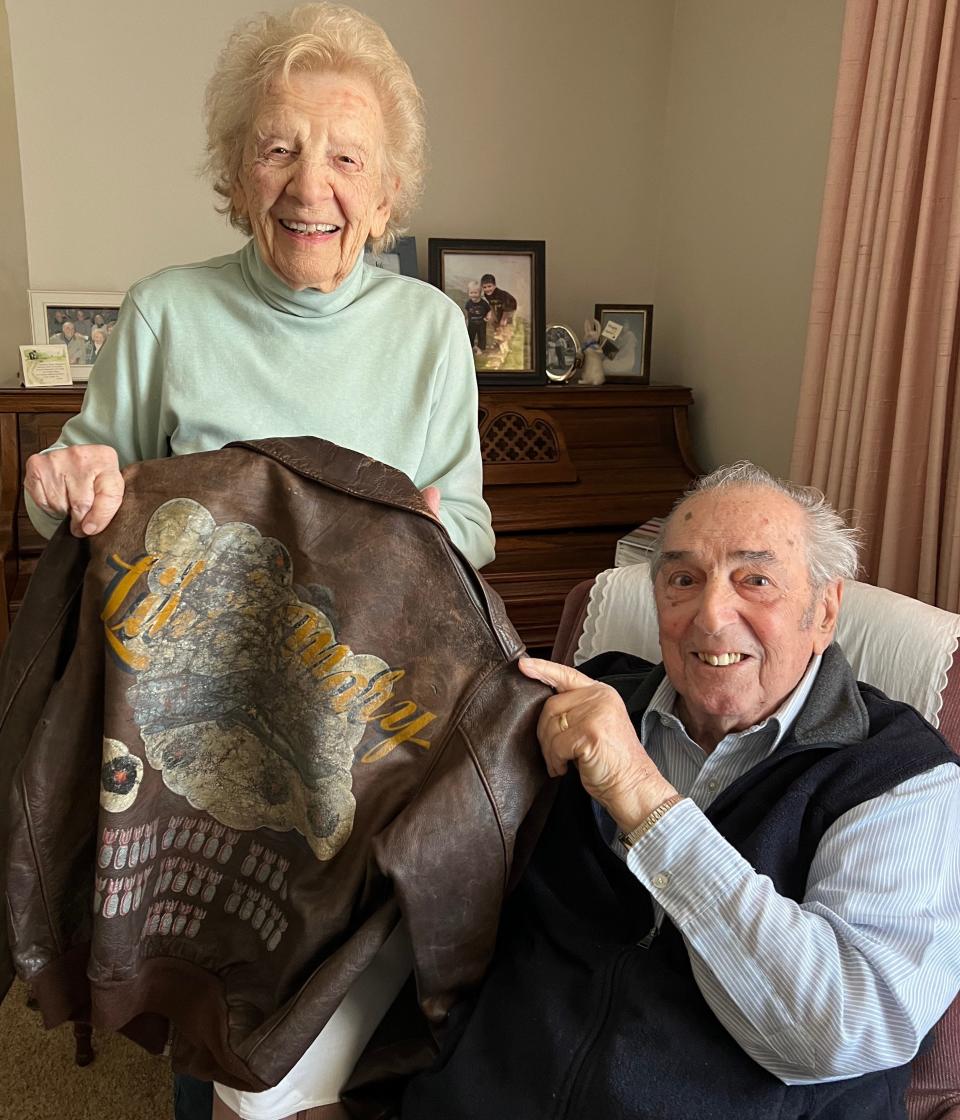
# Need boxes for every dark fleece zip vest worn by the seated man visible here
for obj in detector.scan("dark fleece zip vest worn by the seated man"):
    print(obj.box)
[402,651,956,1120]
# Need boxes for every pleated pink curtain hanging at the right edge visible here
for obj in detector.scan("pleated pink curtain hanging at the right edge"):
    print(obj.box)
[791,0,960,612]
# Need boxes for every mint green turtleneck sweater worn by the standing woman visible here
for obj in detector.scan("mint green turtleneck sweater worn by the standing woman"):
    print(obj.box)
[28,241,493,567]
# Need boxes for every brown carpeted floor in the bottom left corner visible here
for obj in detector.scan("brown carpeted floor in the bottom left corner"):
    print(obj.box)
[0,983,173,1120]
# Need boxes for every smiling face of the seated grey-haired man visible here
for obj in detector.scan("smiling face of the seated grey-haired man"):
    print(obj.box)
[655,487,842,750]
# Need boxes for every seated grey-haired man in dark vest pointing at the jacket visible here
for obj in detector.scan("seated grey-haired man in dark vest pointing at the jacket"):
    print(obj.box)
[403,464,960,1120]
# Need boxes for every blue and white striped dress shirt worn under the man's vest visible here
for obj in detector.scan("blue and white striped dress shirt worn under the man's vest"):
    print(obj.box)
[597,657,960,1084]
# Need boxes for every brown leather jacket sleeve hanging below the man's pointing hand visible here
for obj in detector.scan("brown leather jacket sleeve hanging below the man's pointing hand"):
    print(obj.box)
[374,663,552,1025]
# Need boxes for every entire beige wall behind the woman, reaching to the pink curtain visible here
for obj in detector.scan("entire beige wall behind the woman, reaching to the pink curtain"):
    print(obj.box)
[0,0,842,470]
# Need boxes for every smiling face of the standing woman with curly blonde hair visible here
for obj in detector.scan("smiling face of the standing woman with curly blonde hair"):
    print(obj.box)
[234,71,392,291]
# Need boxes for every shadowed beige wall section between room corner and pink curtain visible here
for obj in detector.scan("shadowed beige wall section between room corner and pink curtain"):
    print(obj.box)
[653,0,844,474]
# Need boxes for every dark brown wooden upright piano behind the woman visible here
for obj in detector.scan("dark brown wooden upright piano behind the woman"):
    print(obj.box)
[0,385,698,652]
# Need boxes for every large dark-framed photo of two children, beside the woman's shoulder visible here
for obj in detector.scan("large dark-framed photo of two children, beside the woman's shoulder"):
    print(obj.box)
[428,237,547,385]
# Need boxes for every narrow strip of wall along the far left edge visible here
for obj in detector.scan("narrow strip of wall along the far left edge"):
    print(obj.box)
[0,0,30,385]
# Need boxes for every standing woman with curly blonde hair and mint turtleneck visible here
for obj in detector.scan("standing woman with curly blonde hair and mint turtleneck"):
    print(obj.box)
[26,4,493,1120]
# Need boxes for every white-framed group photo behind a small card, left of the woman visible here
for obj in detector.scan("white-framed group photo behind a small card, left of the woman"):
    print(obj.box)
[29,291,124,381]
